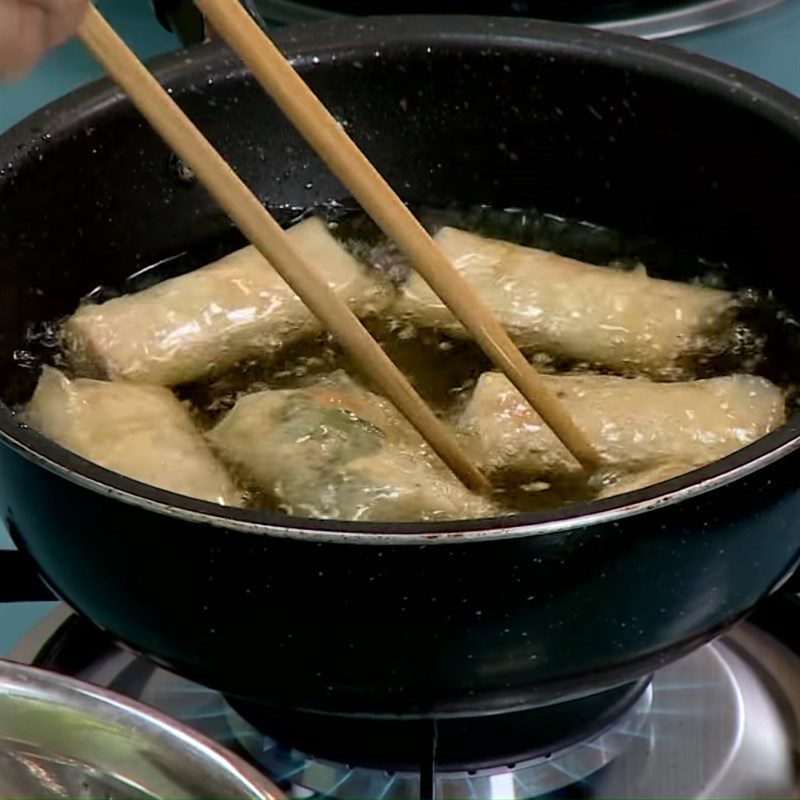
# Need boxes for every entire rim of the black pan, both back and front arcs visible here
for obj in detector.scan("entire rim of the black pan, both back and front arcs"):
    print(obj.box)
[0,15,800,546]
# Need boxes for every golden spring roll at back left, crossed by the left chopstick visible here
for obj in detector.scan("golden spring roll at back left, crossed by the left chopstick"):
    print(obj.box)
[63,218,391,386]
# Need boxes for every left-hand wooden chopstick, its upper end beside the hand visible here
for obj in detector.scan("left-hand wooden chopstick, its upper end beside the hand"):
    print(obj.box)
[79,3,490,491]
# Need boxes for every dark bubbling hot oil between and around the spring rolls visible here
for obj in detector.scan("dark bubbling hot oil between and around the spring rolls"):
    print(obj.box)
[10,204,800,511]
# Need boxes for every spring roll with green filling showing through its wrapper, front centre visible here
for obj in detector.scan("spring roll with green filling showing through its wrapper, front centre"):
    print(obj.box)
[208,380,497,522]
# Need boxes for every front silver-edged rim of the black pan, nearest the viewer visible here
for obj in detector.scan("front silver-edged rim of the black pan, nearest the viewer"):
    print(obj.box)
[0,416,800,546]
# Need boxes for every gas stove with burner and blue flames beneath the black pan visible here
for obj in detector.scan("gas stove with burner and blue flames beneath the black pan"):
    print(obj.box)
[7,597,800,800]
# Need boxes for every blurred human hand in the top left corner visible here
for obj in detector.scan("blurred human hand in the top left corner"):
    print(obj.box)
[0,0,88,78]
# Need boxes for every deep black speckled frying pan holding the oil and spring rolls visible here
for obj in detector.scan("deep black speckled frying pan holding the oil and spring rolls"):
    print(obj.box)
[0,17,800,717]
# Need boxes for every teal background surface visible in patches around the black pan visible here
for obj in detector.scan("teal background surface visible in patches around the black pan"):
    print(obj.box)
[0,0,800,656]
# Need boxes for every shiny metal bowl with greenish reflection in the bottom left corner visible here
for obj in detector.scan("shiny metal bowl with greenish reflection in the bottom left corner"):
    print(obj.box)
[0,661,284,800]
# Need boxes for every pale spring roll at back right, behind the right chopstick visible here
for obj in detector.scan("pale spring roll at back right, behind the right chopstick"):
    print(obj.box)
[394,227,732,379]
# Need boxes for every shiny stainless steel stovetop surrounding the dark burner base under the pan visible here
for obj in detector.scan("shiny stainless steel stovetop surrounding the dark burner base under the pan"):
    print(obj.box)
[7,605,800,800]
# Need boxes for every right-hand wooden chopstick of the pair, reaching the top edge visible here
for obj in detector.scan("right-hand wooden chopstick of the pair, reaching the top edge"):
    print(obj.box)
[194,0,599,471]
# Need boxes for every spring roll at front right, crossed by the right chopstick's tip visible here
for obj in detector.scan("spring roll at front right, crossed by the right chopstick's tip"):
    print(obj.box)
[458,372,785,482]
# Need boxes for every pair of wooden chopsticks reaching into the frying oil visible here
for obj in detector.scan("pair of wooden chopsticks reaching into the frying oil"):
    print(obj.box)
[80,0,598,491]
